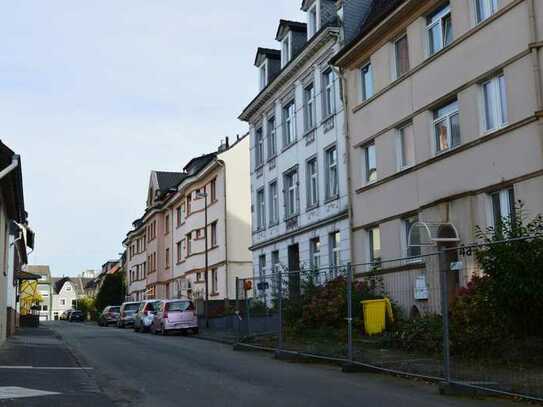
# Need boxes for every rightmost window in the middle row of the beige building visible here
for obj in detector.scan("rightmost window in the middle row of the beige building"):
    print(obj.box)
[481,75,507,131]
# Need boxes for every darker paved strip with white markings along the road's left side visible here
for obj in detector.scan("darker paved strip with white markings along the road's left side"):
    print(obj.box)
[0,327,113,407]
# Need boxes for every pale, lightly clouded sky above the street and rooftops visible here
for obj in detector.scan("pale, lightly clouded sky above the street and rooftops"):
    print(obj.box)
[0,0,303,276]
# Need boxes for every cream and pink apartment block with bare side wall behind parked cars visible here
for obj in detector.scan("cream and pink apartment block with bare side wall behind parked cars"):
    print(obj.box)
[124,137,251,301]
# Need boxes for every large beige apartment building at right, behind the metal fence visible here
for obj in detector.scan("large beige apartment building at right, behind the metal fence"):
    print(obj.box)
[334,0,543,313]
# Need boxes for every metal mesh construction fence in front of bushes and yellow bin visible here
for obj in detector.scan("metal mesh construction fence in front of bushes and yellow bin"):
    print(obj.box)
[226,238,543,401]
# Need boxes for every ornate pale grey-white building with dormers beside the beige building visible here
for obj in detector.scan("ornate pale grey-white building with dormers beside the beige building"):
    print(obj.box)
[240,0,369,294]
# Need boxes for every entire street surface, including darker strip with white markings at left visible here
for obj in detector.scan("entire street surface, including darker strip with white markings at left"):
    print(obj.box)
[0,321,518,407]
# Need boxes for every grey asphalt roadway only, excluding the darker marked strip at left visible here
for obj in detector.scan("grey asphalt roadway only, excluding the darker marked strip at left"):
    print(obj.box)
[34,321,518,407]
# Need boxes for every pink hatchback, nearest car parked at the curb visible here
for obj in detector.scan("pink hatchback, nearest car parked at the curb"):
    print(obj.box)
[151,300,198,335]
